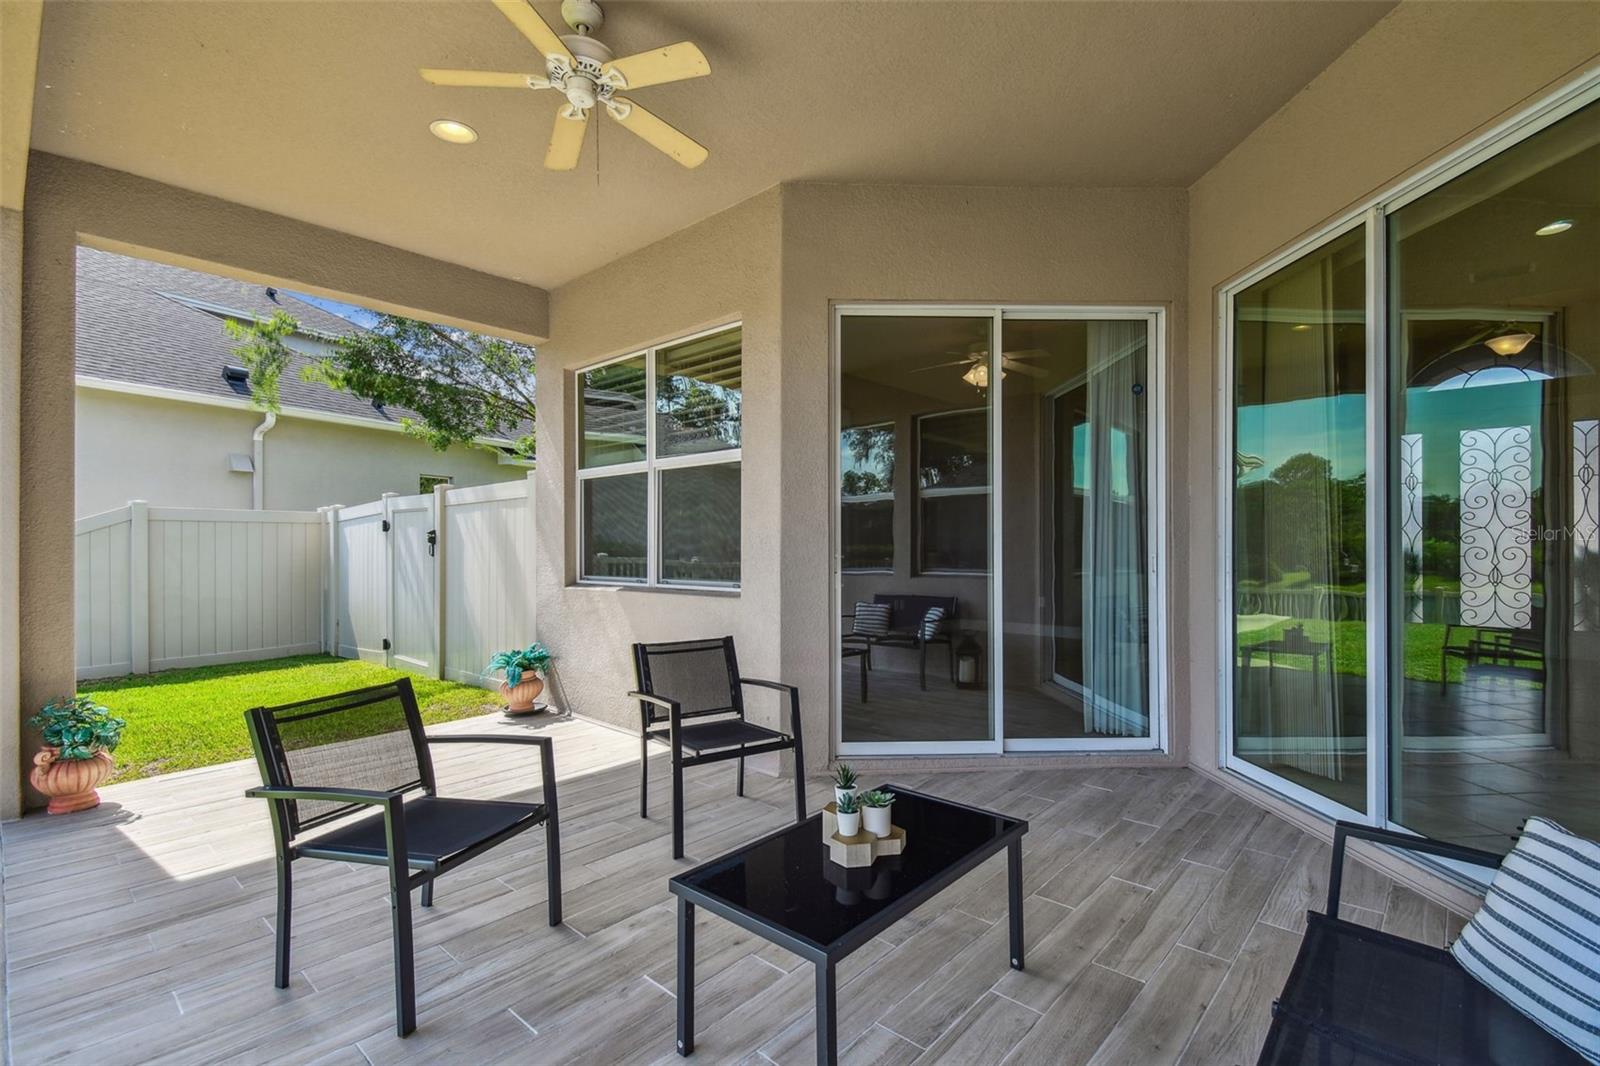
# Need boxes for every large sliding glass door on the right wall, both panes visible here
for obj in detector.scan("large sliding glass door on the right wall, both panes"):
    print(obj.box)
[1219,85,1600,852]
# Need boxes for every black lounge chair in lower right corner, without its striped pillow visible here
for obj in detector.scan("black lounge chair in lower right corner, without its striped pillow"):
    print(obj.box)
[1258,821,1582,1066]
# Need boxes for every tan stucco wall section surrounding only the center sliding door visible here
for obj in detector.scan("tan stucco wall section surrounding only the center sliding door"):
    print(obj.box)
[774,184,1189,762]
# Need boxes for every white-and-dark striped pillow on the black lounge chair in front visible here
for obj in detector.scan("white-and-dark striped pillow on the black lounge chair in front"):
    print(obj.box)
[1450,818,1600,1063]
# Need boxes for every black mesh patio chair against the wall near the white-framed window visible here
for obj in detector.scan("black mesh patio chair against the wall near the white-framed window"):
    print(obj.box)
[627,637,805,858]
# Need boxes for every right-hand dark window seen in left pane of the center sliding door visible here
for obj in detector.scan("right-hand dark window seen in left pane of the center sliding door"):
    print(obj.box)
[917,407,989,575]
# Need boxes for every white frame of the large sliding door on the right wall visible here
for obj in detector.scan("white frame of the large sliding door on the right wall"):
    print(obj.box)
[1216,69,1600,831]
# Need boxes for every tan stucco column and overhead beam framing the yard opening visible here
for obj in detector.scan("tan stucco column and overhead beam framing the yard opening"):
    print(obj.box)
[14,152,549,815]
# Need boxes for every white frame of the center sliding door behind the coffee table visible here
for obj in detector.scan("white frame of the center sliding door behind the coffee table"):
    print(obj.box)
[829,304,1170,755]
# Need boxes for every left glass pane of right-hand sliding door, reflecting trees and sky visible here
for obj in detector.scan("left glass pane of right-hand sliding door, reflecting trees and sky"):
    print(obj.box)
[1230,227,1366,812]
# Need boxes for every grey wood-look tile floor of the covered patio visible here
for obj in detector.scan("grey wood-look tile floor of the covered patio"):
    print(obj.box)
[0,717,1461,1066]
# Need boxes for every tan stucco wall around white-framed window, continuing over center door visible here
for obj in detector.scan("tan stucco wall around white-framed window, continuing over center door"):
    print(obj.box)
[536,184,1186,768]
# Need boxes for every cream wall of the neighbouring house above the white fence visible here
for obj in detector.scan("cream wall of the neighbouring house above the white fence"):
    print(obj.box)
[74,389,526,519]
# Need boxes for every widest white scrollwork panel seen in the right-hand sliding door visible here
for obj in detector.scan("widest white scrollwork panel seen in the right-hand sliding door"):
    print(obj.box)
[1461,426,1533,629]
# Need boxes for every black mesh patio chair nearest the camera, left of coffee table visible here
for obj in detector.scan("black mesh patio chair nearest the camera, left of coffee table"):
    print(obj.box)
[245,679,562,1036]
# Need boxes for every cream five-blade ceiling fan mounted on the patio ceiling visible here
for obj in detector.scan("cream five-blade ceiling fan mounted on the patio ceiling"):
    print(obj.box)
[419,0,710,170]
